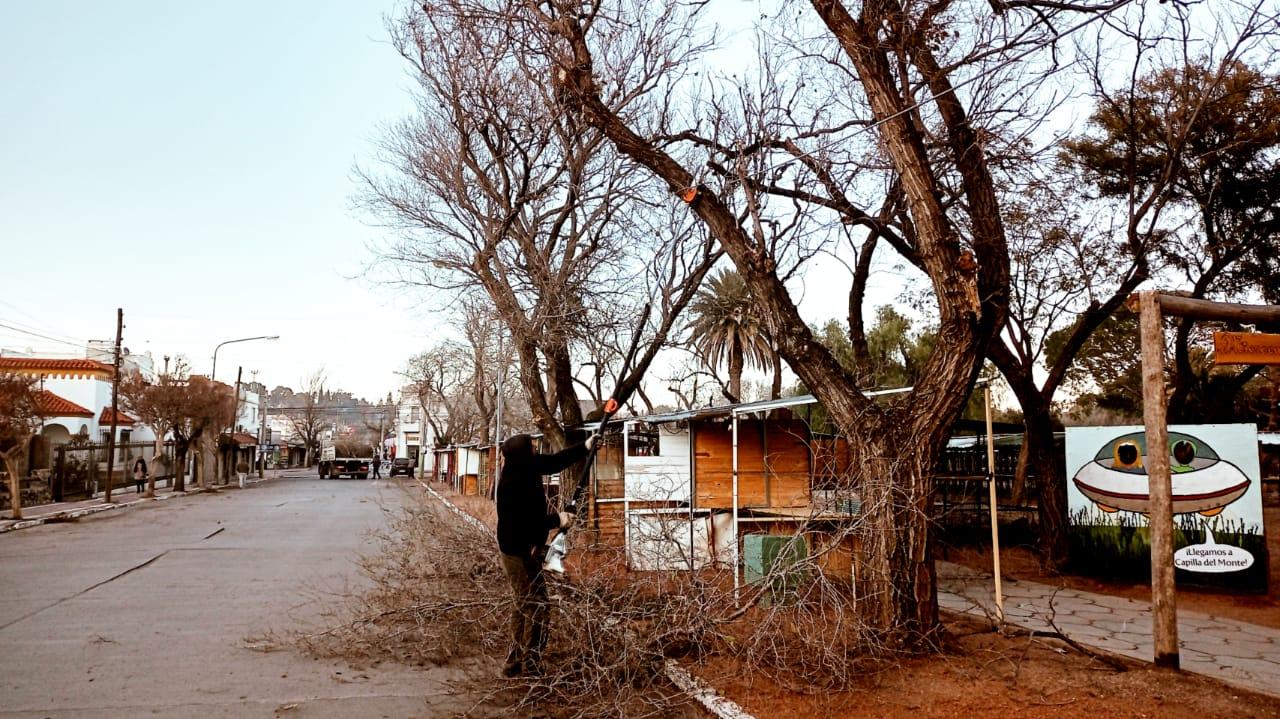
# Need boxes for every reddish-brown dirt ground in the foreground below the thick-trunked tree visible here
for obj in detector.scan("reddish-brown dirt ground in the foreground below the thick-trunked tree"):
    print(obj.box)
[692,608,1280,719]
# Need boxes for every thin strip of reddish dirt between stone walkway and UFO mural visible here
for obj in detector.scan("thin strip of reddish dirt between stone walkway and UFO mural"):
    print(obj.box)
[946,503,1280,628]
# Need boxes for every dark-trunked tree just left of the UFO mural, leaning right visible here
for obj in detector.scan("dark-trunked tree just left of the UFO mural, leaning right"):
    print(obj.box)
[991,3,1277,569]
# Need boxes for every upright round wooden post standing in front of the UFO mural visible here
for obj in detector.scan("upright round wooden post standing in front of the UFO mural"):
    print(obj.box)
[1138,292,1179,669]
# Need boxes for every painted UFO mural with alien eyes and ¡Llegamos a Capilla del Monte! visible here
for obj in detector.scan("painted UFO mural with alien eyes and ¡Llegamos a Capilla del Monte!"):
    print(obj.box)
[1066,425,1267,591]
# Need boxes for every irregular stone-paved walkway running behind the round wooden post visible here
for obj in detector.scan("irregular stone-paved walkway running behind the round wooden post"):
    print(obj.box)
[937,562,1280,696]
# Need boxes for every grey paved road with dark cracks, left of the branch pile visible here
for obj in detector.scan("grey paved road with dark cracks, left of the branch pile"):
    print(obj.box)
[0,472,496,719]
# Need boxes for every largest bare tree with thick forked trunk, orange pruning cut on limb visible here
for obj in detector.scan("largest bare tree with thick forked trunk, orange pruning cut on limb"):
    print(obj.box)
[522,1,1009,641]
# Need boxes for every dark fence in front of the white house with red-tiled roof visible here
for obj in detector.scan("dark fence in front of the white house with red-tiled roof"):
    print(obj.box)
[50,441,175,502]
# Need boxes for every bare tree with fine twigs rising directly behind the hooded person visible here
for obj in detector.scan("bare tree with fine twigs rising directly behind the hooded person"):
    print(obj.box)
[366,4,719,445]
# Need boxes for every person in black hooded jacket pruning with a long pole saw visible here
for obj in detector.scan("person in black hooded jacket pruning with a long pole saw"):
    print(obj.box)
[498,435,595,677]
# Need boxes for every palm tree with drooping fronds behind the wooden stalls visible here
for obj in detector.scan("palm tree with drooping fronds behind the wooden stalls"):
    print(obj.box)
[689,269,777,402]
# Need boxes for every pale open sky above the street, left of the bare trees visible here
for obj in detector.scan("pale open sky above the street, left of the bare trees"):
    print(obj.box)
[0,0,436,398]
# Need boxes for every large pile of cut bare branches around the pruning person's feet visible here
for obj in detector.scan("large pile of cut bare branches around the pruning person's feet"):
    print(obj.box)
[298,488,901,718]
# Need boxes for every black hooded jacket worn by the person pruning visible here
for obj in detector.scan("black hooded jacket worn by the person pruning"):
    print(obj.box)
[498,435,588,557]
